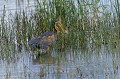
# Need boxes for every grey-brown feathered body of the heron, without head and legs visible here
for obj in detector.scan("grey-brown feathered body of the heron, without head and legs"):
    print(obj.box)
[29,32,57,49]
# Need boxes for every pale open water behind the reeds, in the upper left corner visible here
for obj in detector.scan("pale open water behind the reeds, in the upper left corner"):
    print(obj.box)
[0,0,35,20]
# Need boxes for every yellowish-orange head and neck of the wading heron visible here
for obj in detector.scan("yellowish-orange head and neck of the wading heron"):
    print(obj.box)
[55,17,65,33]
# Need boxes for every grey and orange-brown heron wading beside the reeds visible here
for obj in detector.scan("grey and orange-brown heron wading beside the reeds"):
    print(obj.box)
[29,17,65,53]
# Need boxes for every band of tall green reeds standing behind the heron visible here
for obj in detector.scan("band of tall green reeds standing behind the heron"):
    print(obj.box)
[0,0,120,55]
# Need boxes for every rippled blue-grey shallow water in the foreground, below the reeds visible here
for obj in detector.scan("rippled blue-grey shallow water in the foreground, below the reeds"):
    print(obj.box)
[0,46,120,79]
